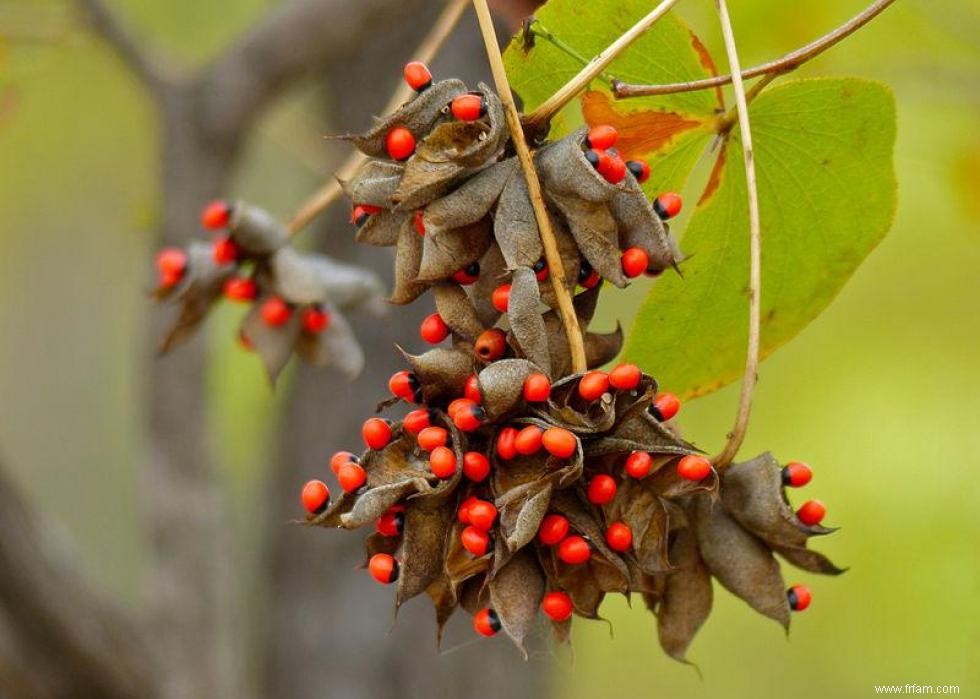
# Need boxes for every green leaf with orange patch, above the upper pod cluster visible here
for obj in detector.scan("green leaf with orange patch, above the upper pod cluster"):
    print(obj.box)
[504,0,723,196]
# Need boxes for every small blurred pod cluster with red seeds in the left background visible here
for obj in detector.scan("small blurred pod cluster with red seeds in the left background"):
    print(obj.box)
[154,202,385,381]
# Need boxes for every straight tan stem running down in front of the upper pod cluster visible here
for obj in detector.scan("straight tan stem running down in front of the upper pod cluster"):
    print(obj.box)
[473,0,588,373]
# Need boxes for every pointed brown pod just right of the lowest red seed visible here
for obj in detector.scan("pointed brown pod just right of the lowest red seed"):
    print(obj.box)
[490,548,544,658]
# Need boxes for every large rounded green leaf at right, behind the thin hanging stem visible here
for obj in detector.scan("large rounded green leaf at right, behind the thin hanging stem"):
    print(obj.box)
[625,78,896,397]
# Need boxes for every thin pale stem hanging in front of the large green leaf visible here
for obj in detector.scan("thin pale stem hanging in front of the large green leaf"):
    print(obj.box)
[711,0,762,469]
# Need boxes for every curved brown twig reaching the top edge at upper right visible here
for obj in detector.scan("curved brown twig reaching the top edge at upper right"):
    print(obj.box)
[613,0,895,98]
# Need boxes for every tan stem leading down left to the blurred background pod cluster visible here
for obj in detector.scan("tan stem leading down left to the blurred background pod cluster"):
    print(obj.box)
[286,0,469,235]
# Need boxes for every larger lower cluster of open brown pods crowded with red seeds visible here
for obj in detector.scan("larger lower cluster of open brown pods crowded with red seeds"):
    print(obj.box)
[307,360,841,660]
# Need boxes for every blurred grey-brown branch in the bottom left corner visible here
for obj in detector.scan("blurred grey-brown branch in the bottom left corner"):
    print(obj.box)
[0,462,155,699]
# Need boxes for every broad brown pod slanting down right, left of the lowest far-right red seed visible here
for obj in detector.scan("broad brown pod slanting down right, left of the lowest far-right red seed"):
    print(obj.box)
[688,494,789,629]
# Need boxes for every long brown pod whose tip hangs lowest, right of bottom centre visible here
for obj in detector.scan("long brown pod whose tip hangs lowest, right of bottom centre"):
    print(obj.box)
[657,529,712,662]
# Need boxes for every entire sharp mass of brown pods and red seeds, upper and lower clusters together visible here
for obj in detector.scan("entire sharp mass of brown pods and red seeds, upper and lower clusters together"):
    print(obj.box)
[303,76,841,660]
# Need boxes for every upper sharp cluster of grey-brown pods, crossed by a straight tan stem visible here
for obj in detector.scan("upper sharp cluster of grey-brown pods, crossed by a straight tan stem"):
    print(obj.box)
[343,80,679,379]
